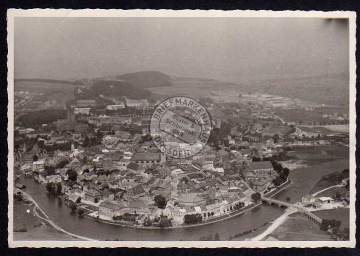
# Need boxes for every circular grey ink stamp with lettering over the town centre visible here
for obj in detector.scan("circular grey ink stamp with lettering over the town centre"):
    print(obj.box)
[150,97,212,158]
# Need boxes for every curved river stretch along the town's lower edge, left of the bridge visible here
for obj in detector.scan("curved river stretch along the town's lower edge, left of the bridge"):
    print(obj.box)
[20,176,284,241]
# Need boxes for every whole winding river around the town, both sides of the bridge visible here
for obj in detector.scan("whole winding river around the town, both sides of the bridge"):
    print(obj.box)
[20,156,349,241]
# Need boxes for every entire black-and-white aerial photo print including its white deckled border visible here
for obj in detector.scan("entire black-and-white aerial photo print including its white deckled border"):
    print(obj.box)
[8,10,356,247]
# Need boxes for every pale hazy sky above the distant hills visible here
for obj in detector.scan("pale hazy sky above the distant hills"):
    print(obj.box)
[15,18,349,81]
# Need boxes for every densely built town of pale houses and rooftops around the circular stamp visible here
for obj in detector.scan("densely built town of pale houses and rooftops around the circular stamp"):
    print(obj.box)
[14,84,349,234]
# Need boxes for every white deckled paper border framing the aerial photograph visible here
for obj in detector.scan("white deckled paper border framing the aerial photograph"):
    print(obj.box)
[7,9,357,248]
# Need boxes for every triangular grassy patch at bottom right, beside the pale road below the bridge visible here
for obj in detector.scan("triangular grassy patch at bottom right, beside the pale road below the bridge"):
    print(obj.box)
[271,213,331,241]
